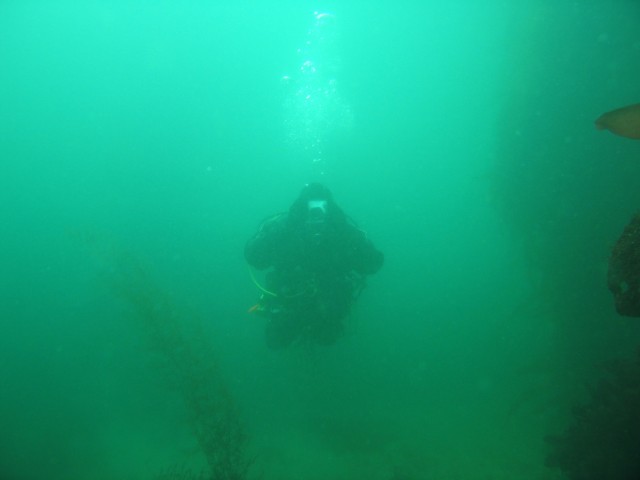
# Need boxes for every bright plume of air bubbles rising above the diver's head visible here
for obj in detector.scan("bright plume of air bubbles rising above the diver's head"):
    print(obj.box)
[282,12,353,176]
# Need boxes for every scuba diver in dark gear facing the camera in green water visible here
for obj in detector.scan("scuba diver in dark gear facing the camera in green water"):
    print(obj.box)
[244,183,384,349]
